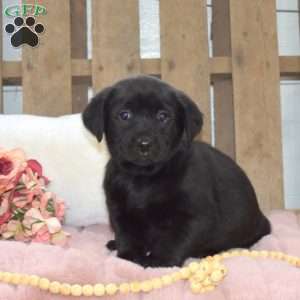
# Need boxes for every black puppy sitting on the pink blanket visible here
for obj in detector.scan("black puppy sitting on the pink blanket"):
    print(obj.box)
[83,76,270,267]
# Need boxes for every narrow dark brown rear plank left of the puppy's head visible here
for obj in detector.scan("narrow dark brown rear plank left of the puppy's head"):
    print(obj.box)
[71,0,88,113]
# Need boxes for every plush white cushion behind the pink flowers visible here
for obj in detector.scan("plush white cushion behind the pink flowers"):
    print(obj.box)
[0,114,109,226]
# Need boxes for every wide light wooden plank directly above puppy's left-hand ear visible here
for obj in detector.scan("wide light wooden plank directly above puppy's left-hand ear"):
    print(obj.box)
[92,0,141,91]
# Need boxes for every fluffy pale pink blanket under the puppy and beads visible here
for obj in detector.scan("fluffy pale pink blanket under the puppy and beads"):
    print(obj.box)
[0,211,300,300]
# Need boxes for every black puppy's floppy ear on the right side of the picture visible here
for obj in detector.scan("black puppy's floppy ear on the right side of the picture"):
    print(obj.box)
[177,91,203,141]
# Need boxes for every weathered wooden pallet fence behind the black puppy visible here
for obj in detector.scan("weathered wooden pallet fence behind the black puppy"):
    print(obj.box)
[0,0,300,211]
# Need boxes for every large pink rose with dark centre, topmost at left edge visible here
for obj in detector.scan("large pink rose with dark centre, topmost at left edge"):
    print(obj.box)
[0,149,26,195]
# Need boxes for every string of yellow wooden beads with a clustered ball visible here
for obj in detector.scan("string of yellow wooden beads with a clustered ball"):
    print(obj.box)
[0,250,300,296]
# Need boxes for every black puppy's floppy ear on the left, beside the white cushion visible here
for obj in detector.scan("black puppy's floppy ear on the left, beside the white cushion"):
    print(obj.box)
[82,87,112,142]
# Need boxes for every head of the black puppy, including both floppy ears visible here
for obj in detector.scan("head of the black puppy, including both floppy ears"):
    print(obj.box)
[82,76,202,166]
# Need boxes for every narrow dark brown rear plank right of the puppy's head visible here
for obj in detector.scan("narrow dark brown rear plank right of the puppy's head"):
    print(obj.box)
[212,0,235,159]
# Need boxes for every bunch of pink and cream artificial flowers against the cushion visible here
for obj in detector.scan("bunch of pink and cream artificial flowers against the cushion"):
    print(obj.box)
[0,148,69,245]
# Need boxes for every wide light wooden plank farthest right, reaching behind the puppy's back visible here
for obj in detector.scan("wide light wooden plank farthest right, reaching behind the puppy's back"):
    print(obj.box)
[230,0,283,211]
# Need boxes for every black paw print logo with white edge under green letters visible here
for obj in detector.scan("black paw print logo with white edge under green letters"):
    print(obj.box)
[5,16,45,47]
